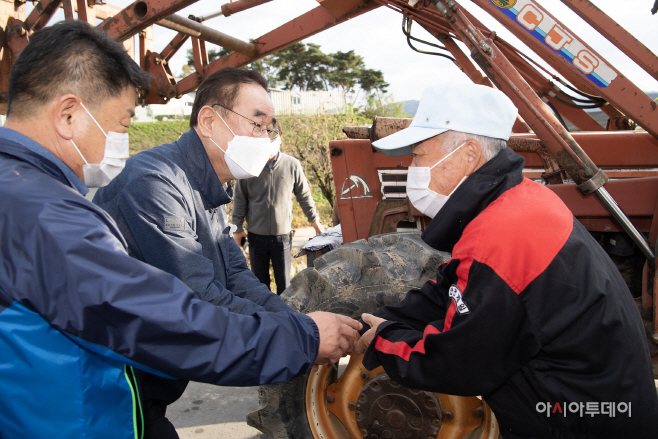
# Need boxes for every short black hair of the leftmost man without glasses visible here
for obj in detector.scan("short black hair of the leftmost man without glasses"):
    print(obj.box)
[7,20,151,118]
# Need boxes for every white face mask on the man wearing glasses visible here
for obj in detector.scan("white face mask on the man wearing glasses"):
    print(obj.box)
[209,111,281,180]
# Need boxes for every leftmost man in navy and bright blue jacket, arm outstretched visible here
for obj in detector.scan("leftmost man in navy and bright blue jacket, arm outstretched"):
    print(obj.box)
[0,21,360,439]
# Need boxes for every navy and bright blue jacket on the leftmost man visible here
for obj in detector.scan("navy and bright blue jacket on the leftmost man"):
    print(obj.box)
[0,128,319,439]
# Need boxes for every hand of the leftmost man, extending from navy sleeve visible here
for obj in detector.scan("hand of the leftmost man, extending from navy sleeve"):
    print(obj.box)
[308,311,363,364]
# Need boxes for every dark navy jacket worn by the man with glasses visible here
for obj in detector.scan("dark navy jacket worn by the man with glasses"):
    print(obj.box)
[94,129,291,314]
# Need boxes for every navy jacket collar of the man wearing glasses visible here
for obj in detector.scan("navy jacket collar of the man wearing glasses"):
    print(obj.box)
[178,128,233,208]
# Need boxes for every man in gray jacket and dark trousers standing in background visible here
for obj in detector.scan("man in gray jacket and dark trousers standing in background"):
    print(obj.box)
[232,151,324,294]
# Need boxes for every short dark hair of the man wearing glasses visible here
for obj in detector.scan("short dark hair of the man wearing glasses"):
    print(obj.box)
[190,67,267,128]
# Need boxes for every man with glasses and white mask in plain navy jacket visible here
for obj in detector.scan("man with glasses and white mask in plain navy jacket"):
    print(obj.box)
[94,67,304,439]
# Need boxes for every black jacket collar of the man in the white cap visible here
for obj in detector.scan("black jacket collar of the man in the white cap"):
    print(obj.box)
[421,148,525,252]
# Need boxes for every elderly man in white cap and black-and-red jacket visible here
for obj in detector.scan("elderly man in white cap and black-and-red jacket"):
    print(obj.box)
[355,84,658,439]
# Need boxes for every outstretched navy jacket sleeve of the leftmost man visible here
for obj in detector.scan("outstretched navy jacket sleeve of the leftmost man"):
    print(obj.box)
[5,198,319,386]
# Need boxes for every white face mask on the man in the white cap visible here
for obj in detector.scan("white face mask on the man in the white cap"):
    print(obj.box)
[407,142,466,218]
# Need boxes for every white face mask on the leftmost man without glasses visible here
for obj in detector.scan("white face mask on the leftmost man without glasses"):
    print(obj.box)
[71,102,130,187]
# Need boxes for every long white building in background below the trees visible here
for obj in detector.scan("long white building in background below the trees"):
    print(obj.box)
[268,88,345,116]
